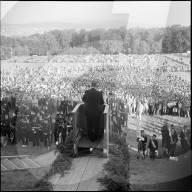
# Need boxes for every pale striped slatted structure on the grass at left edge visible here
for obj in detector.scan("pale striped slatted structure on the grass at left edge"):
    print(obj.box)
[1,155,41,171]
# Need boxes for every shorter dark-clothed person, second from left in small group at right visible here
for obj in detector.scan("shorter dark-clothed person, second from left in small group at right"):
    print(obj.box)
[148,134,158,160]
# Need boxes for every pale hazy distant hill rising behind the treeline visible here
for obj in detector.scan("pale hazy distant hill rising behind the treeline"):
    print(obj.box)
[1,20,159,36]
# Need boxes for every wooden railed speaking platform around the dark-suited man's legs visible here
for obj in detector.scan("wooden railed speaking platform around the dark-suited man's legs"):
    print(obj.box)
[72,103,109,157]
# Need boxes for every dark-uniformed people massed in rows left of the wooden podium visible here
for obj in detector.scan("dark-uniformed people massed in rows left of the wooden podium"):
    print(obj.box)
[1,93,76,147]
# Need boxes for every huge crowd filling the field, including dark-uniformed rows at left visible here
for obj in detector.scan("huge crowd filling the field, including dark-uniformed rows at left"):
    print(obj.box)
[1,55,191,154]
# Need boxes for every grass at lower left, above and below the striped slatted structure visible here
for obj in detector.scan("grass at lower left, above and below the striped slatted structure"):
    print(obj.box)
[1,143,55,191]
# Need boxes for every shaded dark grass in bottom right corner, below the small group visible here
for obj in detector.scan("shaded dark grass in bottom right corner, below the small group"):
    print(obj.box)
[129,149,191,191]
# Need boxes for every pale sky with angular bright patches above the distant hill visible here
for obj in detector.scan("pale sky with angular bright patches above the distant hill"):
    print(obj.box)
[1,1,191,27]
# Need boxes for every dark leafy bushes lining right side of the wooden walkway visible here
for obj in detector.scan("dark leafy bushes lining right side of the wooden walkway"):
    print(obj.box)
[98,134,131,191]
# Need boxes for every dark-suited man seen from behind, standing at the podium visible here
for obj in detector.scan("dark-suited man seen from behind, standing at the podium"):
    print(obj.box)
[82,80,104,142]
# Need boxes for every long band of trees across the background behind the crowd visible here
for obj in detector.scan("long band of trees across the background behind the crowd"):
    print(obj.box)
[1,25,191,59]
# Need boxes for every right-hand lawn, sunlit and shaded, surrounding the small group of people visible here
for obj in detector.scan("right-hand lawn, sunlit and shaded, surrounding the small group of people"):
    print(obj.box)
[125,116,192,191]
